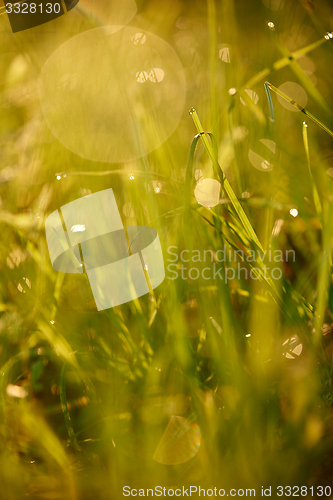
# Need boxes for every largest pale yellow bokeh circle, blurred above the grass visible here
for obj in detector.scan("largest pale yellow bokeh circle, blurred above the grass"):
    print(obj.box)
[39,26,186,163]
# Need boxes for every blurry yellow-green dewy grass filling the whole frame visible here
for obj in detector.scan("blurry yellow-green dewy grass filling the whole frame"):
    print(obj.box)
[0,0,333,500]
